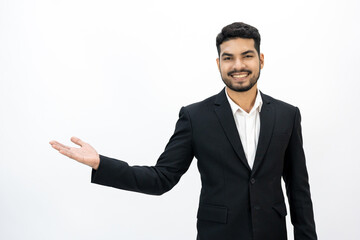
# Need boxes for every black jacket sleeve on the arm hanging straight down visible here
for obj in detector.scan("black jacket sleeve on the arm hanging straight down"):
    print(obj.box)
[283,108,317,240]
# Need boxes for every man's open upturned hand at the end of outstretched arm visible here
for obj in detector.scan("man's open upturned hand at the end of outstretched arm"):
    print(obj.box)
[50,137,100,170]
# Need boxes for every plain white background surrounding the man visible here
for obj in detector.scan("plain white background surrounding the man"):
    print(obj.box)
[0,0,360,240]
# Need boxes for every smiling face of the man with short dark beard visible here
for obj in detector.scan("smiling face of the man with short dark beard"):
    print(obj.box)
[216,38,264,92]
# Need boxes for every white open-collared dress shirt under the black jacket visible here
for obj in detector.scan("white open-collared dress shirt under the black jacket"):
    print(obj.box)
[225,89,263,169]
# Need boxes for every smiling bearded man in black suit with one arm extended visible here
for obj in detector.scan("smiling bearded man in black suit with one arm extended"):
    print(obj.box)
[50,23,317,240]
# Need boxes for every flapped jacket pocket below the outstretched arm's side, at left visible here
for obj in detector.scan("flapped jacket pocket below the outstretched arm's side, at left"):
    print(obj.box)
[197,204,228,223]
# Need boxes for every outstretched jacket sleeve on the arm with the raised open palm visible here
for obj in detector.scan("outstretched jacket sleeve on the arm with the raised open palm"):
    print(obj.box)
[91,107,194,195]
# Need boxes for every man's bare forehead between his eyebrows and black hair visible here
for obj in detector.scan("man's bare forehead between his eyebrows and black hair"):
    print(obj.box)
[220,38,256,55]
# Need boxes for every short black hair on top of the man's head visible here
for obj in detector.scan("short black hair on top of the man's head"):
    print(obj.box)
[216,22,261,56]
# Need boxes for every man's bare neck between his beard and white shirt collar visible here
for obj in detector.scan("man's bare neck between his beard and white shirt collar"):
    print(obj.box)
[225,84,257,113]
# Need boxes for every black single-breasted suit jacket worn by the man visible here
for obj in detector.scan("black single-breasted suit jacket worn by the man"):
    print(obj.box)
[92,89,317,240]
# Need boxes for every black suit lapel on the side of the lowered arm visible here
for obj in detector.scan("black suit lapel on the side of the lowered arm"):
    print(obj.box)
[252,93,275,175]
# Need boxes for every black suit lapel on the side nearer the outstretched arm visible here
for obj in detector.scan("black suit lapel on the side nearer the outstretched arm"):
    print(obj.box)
[215,88,250,171]
